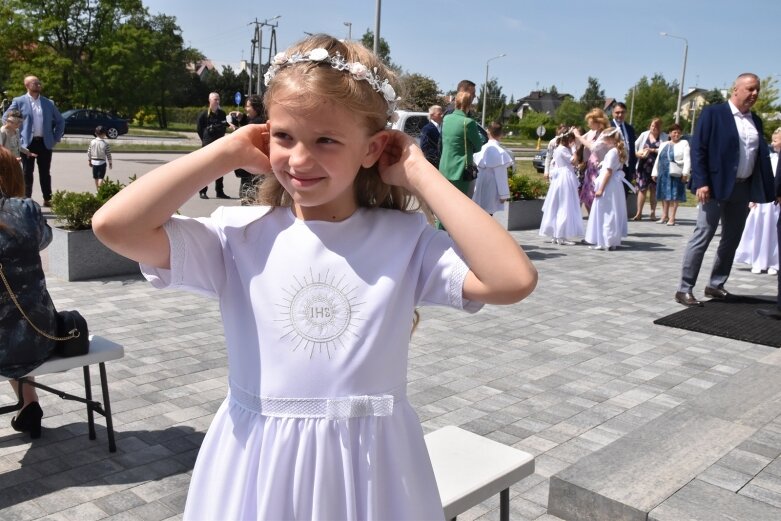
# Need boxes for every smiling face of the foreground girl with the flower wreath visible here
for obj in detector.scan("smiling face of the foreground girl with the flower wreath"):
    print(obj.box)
[268,101,388,221]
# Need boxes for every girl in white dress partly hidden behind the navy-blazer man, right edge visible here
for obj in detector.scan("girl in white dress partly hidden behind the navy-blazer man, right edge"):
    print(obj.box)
[735,128,781,275]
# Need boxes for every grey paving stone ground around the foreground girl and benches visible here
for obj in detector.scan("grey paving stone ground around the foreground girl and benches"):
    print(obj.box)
[0,204,781,521]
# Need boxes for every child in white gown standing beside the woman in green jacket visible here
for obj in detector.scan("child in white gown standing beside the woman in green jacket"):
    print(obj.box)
[472,121,513,215]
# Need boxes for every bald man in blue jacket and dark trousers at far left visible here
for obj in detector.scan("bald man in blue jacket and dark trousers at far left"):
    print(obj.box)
[3,76,65,206]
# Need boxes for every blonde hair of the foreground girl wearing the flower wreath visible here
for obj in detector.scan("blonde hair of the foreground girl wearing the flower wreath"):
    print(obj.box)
[256,34,420,212]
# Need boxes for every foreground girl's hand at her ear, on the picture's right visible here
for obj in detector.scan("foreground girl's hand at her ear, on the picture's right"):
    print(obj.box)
[377,130,434,192]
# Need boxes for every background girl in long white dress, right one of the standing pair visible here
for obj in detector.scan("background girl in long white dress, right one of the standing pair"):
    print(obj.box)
[586,128,629,250]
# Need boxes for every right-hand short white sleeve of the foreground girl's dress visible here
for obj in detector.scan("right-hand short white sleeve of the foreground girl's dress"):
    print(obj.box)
[416,217,483,313]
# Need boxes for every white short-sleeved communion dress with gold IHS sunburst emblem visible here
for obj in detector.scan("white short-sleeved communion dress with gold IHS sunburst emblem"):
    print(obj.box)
[142,207,482,521]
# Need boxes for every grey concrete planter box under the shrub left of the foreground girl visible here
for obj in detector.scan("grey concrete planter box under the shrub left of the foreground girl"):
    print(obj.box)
[48,227,141,281]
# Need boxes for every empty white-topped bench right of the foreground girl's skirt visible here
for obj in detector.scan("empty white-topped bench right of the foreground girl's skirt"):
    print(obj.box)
[425,425,534,521]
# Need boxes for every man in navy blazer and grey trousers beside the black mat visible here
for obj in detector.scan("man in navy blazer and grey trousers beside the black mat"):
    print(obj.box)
[675,73,776,306]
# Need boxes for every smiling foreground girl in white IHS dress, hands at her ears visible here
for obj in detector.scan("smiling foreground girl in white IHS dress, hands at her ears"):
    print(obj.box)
[93,35,537,520]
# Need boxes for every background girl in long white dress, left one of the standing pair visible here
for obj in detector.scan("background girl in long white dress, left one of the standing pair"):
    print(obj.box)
[540,132,583,245]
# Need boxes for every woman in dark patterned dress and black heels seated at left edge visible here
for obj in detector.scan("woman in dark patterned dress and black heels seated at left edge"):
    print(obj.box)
[0,147,57,438]
